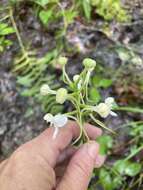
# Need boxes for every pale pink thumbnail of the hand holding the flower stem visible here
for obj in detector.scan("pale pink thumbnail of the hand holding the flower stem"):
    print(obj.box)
[87,142,99,160]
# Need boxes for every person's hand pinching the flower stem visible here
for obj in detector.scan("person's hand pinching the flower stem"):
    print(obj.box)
[0,121,105,190]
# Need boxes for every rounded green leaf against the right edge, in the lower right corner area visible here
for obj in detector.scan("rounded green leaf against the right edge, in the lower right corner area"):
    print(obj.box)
[125,163,142,177]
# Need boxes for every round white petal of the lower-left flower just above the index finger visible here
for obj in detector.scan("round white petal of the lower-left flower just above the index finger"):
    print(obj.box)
[54,114,68,127]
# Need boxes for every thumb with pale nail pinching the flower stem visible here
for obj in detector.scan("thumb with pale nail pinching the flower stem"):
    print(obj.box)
[57,142,99,190]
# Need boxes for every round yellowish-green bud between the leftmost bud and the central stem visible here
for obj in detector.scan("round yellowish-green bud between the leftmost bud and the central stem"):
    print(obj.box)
[56,88,68,104]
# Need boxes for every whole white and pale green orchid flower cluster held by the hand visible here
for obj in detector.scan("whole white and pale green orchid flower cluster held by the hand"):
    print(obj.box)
[40,57,117,143]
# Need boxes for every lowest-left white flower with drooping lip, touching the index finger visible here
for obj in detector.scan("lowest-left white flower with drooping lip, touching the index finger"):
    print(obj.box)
[44,113,68,139]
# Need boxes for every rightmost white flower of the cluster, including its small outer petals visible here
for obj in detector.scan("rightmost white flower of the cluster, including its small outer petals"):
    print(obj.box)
[94,97,117,118]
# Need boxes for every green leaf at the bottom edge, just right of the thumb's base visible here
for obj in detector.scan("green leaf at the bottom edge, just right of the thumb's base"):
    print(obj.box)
[99,168,113,190]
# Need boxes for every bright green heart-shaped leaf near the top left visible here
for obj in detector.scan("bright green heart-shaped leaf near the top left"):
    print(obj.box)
[39,10,53,25]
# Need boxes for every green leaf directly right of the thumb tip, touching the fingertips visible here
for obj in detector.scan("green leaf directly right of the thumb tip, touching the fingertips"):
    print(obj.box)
[97,135,113,155]
